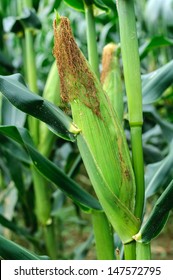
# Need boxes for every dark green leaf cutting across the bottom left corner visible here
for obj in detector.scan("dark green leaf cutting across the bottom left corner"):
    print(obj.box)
[0,235,41,260]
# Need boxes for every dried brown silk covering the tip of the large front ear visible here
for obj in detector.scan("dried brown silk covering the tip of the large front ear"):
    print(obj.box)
[53,17,100,115]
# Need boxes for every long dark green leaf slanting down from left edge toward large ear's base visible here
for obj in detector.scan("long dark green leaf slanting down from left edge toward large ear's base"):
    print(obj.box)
[0,126,101,211]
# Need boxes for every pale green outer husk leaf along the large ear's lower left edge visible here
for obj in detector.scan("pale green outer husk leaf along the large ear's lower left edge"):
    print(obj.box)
[77,135,139,243]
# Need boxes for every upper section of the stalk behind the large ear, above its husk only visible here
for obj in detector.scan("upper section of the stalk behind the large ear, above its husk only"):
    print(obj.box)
[84,0,100,77]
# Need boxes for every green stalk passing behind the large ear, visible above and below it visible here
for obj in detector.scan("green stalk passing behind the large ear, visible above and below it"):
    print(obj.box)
[84,0,115,260]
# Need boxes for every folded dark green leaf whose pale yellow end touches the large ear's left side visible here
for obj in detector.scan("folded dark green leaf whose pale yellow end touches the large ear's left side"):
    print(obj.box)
[0,74,79,141]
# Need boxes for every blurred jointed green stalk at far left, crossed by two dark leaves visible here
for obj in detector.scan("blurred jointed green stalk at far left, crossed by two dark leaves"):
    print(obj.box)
[23,0,57,259]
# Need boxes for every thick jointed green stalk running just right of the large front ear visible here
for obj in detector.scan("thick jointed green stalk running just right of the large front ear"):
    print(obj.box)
[117,0,146,259]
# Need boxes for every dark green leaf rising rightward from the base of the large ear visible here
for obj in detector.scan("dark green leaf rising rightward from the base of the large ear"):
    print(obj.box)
[134,180,173,243]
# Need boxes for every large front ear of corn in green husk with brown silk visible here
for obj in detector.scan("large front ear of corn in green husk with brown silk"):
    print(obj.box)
[54,17,138,242]
